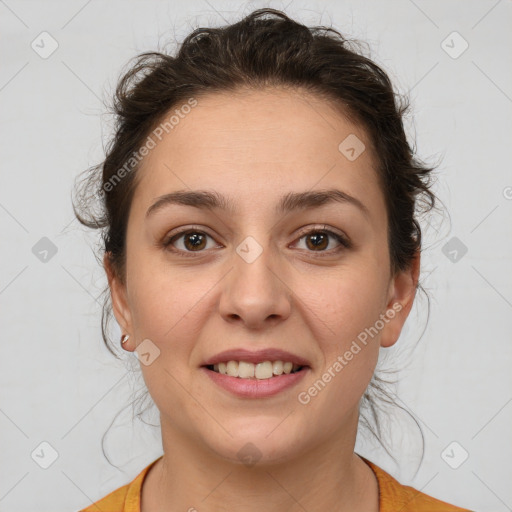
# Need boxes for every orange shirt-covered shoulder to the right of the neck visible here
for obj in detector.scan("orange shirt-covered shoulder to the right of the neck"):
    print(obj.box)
[359,455,471,512]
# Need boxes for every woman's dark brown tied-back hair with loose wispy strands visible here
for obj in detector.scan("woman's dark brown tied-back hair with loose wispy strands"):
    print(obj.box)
[73,9,436,466]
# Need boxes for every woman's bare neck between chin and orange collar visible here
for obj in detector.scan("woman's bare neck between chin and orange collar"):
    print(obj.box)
[141,408,378,512]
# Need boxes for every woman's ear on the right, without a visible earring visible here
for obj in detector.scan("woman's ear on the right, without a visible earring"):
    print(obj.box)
[380,250,421,347]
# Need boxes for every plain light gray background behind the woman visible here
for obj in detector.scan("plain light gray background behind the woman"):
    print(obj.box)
[0,0,512,512]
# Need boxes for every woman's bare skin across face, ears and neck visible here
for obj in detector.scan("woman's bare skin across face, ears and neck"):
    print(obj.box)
[104,88,420,512]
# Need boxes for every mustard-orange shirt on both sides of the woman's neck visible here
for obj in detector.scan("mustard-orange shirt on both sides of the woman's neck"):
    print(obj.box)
[80,455,471,512]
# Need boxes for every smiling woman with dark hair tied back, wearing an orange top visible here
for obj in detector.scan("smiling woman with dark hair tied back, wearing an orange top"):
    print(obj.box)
[77,9,474,512]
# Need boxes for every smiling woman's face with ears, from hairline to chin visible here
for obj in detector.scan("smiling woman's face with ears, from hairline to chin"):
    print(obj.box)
[107,89,419,462]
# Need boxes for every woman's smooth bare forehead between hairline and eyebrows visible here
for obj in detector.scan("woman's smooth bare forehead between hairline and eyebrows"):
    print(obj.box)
[134,88,383,222]
